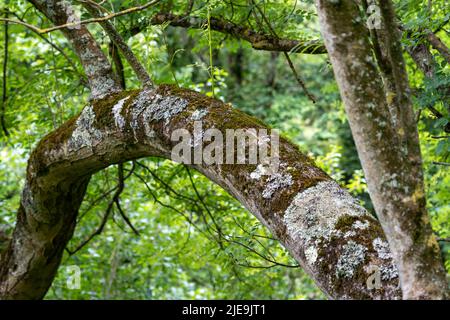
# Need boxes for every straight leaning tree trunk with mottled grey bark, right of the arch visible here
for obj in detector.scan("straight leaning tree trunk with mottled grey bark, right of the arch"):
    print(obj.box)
[316,0,448,299]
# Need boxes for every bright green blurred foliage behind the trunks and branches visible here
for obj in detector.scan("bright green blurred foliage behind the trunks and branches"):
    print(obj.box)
[0,0,450,299]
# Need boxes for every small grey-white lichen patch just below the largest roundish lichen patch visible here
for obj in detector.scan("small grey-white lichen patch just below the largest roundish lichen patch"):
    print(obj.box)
[336,241,367,278]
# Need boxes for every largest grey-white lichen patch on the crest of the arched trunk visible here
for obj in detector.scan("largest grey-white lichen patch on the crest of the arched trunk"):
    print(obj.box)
[130,89,188,137]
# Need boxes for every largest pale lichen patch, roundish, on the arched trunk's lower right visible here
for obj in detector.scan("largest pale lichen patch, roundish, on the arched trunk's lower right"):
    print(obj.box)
[283,181,369,244]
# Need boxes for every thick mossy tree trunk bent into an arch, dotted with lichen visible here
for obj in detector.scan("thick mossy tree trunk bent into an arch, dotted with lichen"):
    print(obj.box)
[0,86,401,299]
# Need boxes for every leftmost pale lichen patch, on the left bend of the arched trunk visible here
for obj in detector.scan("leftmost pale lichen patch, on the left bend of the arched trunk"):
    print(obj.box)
[68,106,102,150]
